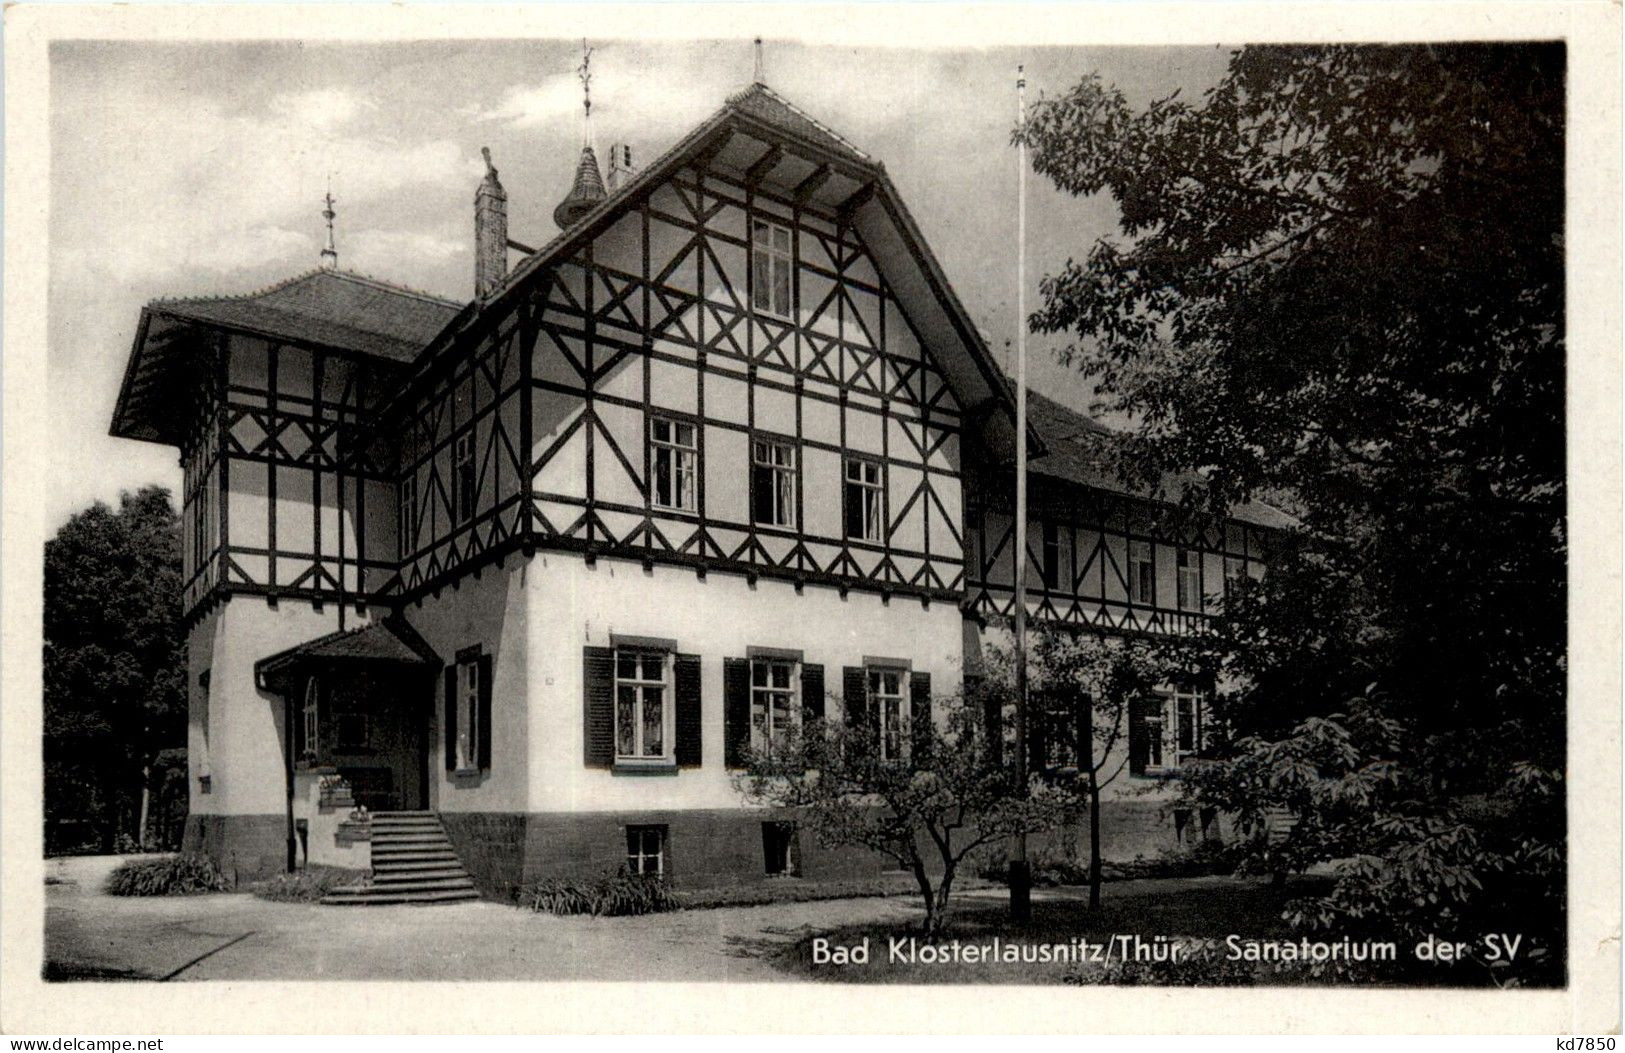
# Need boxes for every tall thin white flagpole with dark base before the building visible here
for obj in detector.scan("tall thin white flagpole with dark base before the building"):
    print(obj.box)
[1009,65,1032,921]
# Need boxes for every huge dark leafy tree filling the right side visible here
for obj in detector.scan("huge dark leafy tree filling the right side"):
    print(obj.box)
[1017,44,1567,981]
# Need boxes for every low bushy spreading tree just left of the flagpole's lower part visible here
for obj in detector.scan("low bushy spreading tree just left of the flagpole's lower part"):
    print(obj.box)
[736,696,1073,936]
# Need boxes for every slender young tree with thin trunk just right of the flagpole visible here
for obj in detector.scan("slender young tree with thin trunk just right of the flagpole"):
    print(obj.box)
[983,631,1191,910]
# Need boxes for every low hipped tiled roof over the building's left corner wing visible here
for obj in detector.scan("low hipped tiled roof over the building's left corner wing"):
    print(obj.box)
[112,268,462,445]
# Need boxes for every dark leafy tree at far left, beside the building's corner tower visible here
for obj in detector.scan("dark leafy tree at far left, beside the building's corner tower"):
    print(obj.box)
[44,486,187,850]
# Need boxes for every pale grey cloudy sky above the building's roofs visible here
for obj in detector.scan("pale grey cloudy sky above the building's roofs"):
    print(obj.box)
[46,34,1229,530]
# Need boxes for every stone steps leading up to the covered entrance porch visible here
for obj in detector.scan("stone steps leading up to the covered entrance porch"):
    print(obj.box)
[322,811,479,907]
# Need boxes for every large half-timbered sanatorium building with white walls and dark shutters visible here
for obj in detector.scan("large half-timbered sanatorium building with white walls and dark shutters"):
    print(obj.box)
[112,85,1284,899]
